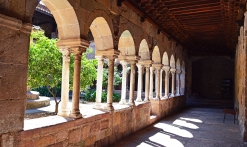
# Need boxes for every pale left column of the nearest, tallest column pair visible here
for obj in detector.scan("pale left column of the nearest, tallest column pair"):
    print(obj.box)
[58,48,70,117]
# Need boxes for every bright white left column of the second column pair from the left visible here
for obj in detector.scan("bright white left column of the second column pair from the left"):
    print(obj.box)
[93,56,104,109]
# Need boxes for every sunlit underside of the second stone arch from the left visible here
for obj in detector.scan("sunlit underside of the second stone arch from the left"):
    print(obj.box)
[90,17,113,50]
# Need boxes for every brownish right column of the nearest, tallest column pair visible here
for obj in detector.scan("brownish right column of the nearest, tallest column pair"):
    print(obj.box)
[69,47,85,118]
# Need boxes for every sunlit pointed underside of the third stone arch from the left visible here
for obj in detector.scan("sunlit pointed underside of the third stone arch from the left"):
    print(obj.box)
[118,30,136,56]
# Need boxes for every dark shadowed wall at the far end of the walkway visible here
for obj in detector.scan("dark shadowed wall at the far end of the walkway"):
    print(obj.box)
[192,57,234,99]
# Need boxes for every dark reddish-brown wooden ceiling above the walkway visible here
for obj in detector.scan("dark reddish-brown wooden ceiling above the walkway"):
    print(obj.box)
[124,0,246,55]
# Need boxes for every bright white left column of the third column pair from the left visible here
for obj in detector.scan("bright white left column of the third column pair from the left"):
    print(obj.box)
[119,61,128,104]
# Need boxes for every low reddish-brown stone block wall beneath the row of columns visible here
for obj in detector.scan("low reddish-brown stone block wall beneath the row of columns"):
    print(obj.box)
[1,96,185,147]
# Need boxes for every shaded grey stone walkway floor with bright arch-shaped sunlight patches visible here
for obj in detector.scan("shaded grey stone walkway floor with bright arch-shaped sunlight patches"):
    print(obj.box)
[112,108,242,147]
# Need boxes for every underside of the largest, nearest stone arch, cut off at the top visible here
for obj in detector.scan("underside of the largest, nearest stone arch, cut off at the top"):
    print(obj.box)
[42,0,80,40]
